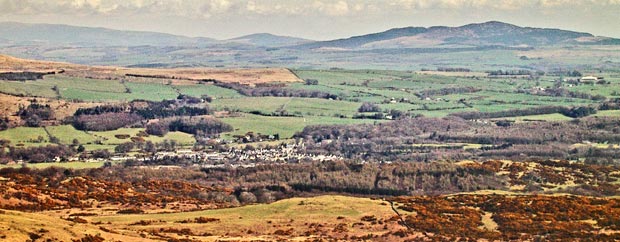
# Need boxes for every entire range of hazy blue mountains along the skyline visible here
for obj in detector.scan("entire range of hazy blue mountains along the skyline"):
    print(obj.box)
[0,21,620,50]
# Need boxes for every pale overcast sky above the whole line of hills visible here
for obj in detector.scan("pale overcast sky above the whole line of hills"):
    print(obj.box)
[0,0,620,40]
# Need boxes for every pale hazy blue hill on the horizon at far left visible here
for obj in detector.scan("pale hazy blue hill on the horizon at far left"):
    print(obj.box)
[0,22,214,46]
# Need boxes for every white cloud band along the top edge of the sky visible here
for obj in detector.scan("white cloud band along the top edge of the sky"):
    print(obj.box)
[0,0,620,17]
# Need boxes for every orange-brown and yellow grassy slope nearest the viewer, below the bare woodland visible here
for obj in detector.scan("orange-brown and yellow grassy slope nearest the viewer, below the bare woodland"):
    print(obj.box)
[0,194,620,241]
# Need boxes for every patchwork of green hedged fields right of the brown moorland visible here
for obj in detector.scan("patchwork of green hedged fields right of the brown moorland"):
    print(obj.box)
[296,70,604,117]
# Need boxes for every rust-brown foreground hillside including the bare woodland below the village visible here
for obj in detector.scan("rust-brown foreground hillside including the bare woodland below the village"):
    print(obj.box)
[0,157,620,241]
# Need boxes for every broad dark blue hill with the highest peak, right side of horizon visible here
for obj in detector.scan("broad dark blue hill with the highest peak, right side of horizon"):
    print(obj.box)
[296,21,619,49]
